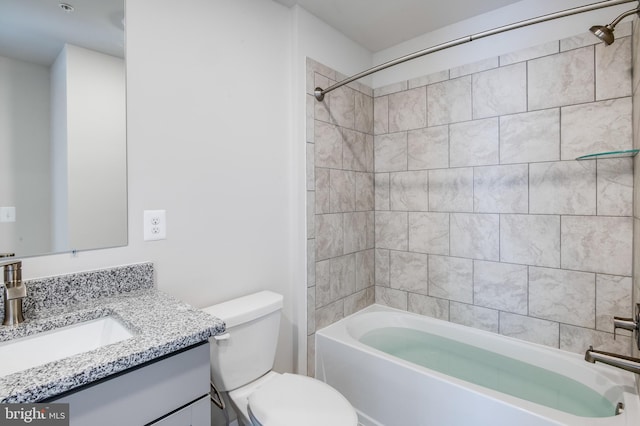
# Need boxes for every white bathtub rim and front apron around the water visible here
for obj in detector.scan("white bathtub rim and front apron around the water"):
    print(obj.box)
[316,305,640,426]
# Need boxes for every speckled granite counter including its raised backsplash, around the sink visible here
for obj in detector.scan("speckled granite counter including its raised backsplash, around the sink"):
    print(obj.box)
[0,264,224,402]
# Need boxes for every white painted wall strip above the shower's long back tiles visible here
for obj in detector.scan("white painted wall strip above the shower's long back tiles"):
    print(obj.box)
[373,0,634,88]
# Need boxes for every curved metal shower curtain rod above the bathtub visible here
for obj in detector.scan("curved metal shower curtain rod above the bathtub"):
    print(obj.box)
[314,0,640,101]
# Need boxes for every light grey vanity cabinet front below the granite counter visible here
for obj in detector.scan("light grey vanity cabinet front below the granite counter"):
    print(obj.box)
[50,342,211,426]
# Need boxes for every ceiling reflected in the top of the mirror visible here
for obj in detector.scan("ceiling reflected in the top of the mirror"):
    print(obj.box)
[0,0,124,65]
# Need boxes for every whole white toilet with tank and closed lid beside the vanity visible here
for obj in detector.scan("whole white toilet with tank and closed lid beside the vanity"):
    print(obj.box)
[203,291,358,426]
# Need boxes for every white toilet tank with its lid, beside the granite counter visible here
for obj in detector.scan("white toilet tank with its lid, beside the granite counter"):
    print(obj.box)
[203,291,282,391]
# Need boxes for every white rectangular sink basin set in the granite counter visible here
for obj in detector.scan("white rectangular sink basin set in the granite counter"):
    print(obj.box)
[0,316,133,376]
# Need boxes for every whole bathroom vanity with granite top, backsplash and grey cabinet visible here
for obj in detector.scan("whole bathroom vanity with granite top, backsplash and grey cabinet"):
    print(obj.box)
[0,264,225,426]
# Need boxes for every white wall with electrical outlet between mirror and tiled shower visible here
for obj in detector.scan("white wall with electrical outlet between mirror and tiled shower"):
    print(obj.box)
[23,0,302,370]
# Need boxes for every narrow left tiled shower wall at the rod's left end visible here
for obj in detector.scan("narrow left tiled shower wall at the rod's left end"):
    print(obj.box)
[307,60,375,375]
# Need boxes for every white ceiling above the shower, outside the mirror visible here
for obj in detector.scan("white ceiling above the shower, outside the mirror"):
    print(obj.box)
[276,0,519,52]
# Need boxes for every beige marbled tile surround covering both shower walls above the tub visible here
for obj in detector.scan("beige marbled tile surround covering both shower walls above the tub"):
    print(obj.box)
[307,25,637,374]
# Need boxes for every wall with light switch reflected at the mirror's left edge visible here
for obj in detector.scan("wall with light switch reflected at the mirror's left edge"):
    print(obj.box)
[0,56,51,253]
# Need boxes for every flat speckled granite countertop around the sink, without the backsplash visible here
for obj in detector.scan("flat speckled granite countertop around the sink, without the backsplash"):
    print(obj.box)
[0,262,225,403]
